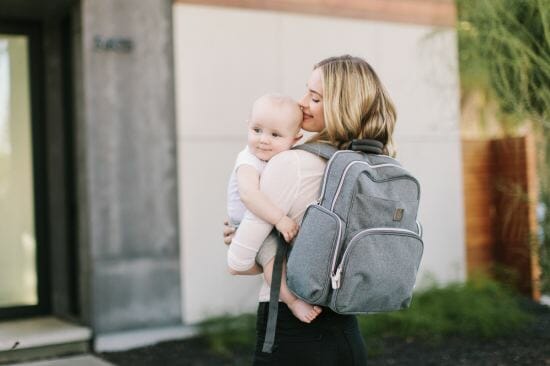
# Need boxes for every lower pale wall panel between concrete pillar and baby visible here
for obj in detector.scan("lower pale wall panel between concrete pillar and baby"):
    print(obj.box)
[179,140,260,323]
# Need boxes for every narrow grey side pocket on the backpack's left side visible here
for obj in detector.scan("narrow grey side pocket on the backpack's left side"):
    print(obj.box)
[287,205,343,306]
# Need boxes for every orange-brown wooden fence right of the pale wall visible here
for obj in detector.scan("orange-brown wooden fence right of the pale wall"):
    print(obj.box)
[462,135,540,299]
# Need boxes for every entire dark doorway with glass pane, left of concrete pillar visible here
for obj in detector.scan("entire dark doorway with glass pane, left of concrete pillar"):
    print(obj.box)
[0,0,80,321]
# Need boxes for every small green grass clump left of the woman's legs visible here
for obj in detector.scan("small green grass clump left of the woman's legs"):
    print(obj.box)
[199,314,256,356]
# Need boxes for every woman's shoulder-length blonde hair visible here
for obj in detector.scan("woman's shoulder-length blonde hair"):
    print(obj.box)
[313,55,396,156]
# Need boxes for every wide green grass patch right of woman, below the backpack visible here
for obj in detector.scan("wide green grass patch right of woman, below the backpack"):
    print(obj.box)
[359,278,531,341]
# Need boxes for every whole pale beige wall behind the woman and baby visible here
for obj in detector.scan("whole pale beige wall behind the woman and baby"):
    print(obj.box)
[174,4,465,322]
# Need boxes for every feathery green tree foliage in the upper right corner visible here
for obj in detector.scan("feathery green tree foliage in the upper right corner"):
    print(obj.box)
[457,0,550,124]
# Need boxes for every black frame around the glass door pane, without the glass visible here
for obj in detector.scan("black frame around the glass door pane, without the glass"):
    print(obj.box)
[0,18,51,321]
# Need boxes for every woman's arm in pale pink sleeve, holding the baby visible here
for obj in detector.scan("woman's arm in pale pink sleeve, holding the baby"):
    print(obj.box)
[231,151,300,274]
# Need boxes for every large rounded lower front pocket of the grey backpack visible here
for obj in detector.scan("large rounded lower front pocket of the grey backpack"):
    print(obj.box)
[332,228,424,314]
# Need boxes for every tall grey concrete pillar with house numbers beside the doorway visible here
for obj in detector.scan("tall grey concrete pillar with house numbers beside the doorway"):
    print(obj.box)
[75,0,181,333]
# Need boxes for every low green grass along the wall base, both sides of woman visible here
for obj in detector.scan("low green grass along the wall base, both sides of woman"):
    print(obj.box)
[199,278,533,356]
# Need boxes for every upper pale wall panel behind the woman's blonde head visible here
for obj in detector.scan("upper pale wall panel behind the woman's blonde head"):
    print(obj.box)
[282,15,459,136]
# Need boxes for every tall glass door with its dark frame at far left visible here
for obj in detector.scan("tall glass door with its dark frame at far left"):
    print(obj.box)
[0,23,45,318]
